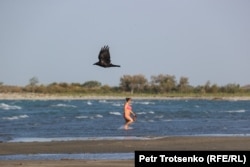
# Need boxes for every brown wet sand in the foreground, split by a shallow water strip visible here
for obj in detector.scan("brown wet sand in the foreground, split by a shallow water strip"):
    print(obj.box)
[0,136,250,167]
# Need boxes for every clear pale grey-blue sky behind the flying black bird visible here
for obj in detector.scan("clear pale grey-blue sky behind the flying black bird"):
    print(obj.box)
[0,0,250,86]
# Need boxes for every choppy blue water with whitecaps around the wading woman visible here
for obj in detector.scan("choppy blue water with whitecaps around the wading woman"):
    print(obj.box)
[0,100,250,142]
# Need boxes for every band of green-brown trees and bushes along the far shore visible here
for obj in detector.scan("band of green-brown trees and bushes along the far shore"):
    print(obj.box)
[0,74,250,95]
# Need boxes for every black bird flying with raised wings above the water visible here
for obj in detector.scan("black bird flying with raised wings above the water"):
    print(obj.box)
[93,45,121,68]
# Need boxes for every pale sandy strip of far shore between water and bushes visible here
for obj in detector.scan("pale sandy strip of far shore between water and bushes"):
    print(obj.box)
[0,93,250,100]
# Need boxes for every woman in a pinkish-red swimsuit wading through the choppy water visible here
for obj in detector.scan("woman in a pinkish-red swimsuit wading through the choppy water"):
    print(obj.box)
[123,98,136,130]
